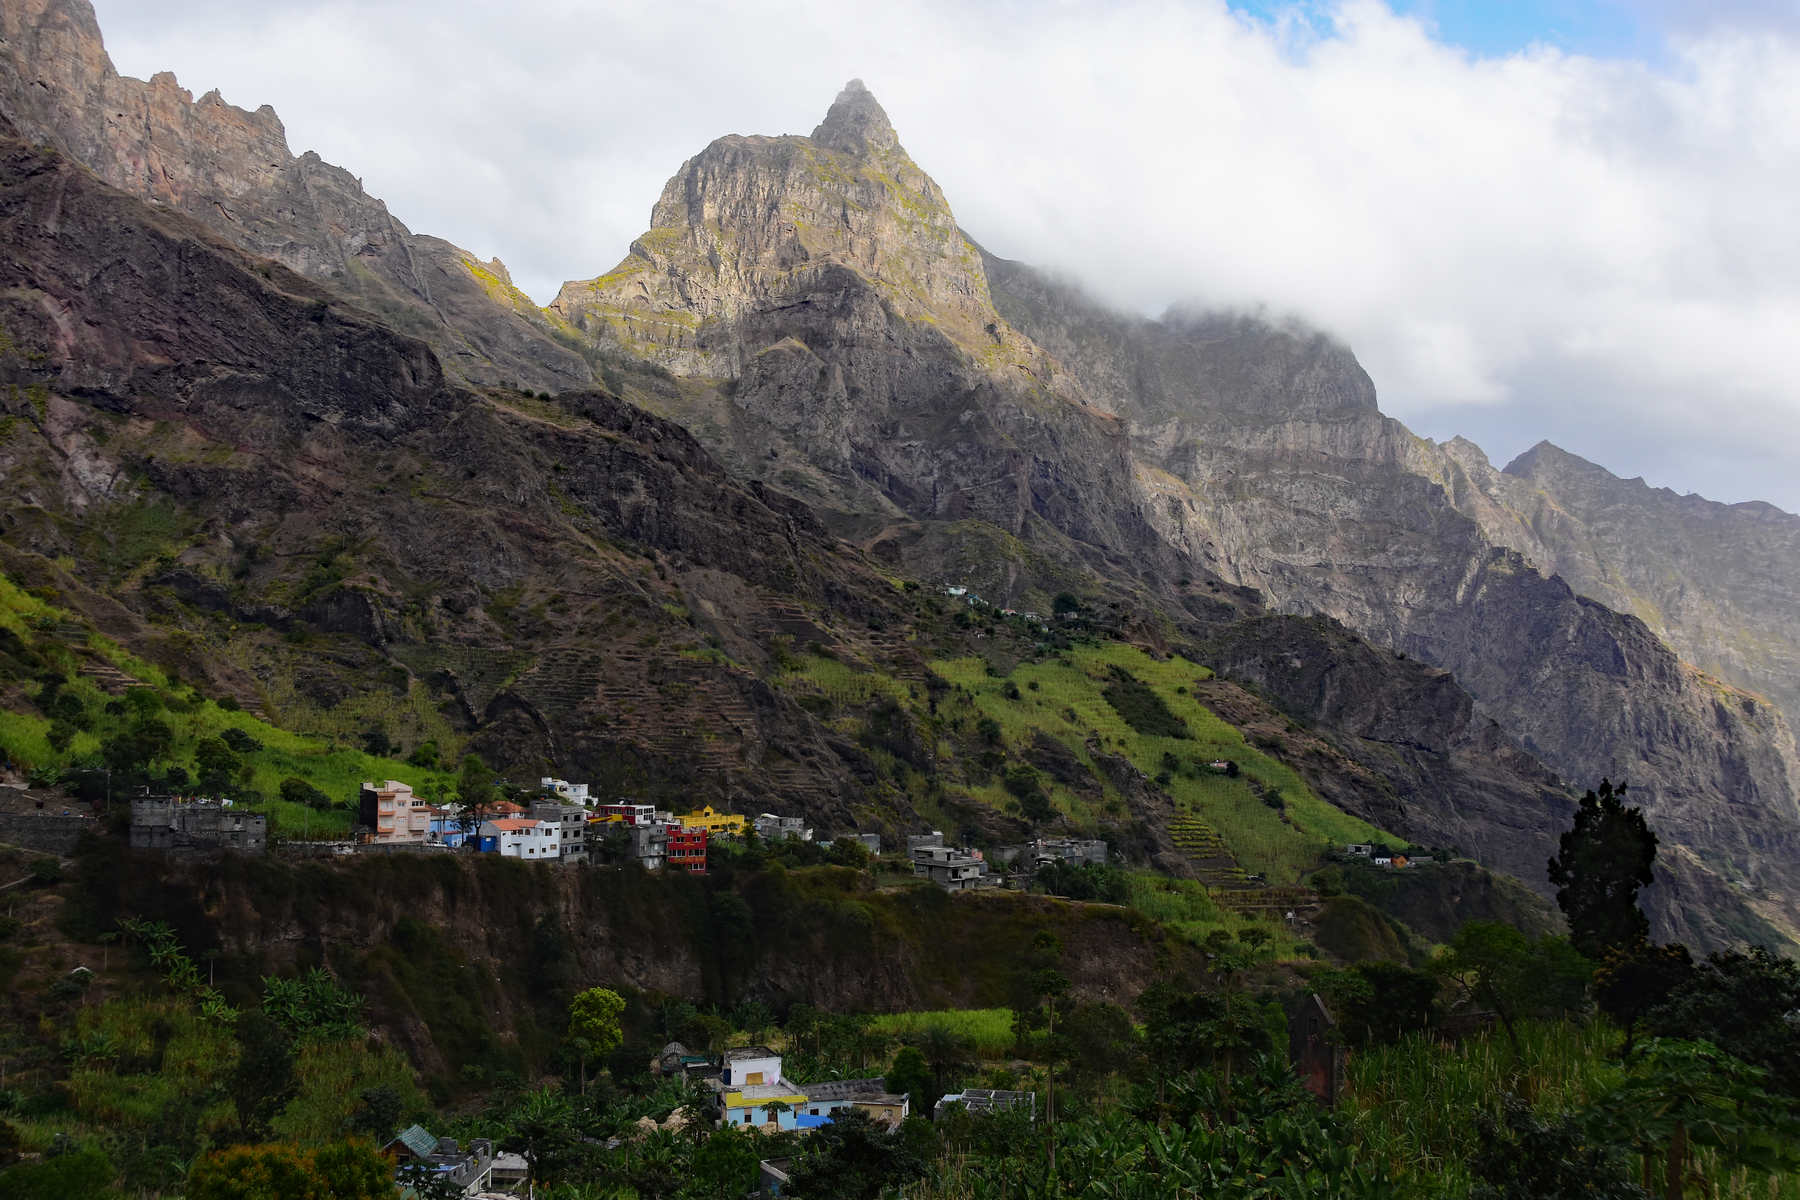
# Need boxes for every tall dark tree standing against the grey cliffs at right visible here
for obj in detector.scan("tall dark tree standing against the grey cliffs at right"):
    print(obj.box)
[1550,779,1656,959]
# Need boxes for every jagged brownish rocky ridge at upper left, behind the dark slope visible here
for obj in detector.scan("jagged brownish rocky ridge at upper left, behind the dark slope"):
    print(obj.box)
[0,0,592,390]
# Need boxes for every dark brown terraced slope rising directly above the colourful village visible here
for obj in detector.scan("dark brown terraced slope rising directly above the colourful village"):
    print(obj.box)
[0,94,1598,942]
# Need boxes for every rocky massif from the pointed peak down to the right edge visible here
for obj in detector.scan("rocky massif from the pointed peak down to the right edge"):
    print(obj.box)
[540,83,1800,949]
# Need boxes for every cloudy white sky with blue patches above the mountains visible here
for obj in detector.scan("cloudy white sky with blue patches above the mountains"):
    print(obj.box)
[94,0,1800,511]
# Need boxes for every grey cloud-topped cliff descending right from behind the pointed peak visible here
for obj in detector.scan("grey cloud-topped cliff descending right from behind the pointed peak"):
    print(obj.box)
[988,259,1800,949]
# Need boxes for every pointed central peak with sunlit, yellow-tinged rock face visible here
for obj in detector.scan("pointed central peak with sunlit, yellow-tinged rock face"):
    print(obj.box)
[553,81,1181,597]
